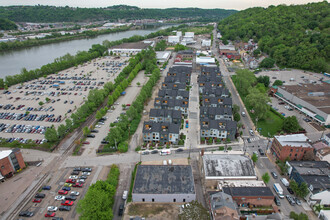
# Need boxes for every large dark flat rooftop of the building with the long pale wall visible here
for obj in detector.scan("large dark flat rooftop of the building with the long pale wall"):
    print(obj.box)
[133,165,195,194]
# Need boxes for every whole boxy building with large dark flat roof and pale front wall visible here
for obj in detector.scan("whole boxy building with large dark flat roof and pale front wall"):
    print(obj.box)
[132,165,196,202]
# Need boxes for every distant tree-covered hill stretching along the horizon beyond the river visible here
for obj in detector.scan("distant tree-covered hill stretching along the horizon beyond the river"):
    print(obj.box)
[0,5,236,22]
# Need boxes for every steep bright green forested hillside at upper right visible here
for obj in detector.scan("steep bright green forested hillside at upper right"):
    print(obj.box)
[218,1,330,72]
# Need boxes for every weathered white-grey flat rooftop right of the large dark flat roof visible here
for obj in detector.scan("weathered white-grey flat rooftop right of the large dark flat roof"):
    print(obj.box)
[203,154,256,179]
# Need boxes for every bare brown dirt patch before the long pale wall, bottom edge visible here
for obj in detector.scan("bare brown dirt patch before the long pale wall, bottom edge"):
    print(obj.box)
[124,203,180,220]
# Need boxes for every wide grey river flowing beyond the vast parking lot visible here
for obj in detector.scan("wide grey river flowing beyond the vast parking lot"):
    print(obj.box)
[0,26,171,78]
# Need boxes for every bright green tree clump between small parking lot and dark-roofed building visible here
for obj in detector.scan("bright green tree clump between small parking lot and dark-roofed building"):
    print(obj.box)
[77,164,120,220]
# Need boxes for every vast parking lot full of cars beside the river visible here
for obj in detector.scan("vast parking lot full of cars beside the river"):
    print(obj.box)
[0,57,128,143]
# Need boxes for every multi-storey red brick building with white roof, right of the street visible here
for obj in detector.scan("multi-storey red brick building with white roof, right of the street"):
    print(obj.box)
[270,134,313,161]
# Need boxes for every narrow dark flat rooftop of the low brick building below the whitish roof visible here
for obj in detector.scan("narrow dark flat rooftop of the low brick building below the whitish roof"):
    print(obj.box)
[223,187,274,197]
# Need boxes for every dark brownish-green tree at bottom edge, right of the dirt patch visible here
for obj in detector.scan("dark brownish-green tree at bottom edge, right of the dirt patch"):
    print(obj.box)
[178,200,210,220]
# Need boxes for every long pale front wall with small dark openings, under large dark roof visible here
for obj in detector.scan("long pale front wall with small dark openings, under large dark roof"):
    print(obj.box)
[132,193,196,202]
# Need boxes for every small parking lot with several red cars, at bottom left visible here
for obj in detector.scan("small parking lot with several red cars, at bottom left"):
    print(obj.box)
[19,168,98,219]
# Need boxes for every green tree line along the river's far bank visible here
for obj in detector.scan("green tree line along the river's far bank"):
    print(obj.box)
[0,26,130,52]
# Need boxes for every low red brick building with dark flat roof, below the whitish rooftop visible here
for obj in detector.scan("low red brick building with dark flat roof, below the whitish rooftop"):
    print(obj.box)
[223,187,274,207]
